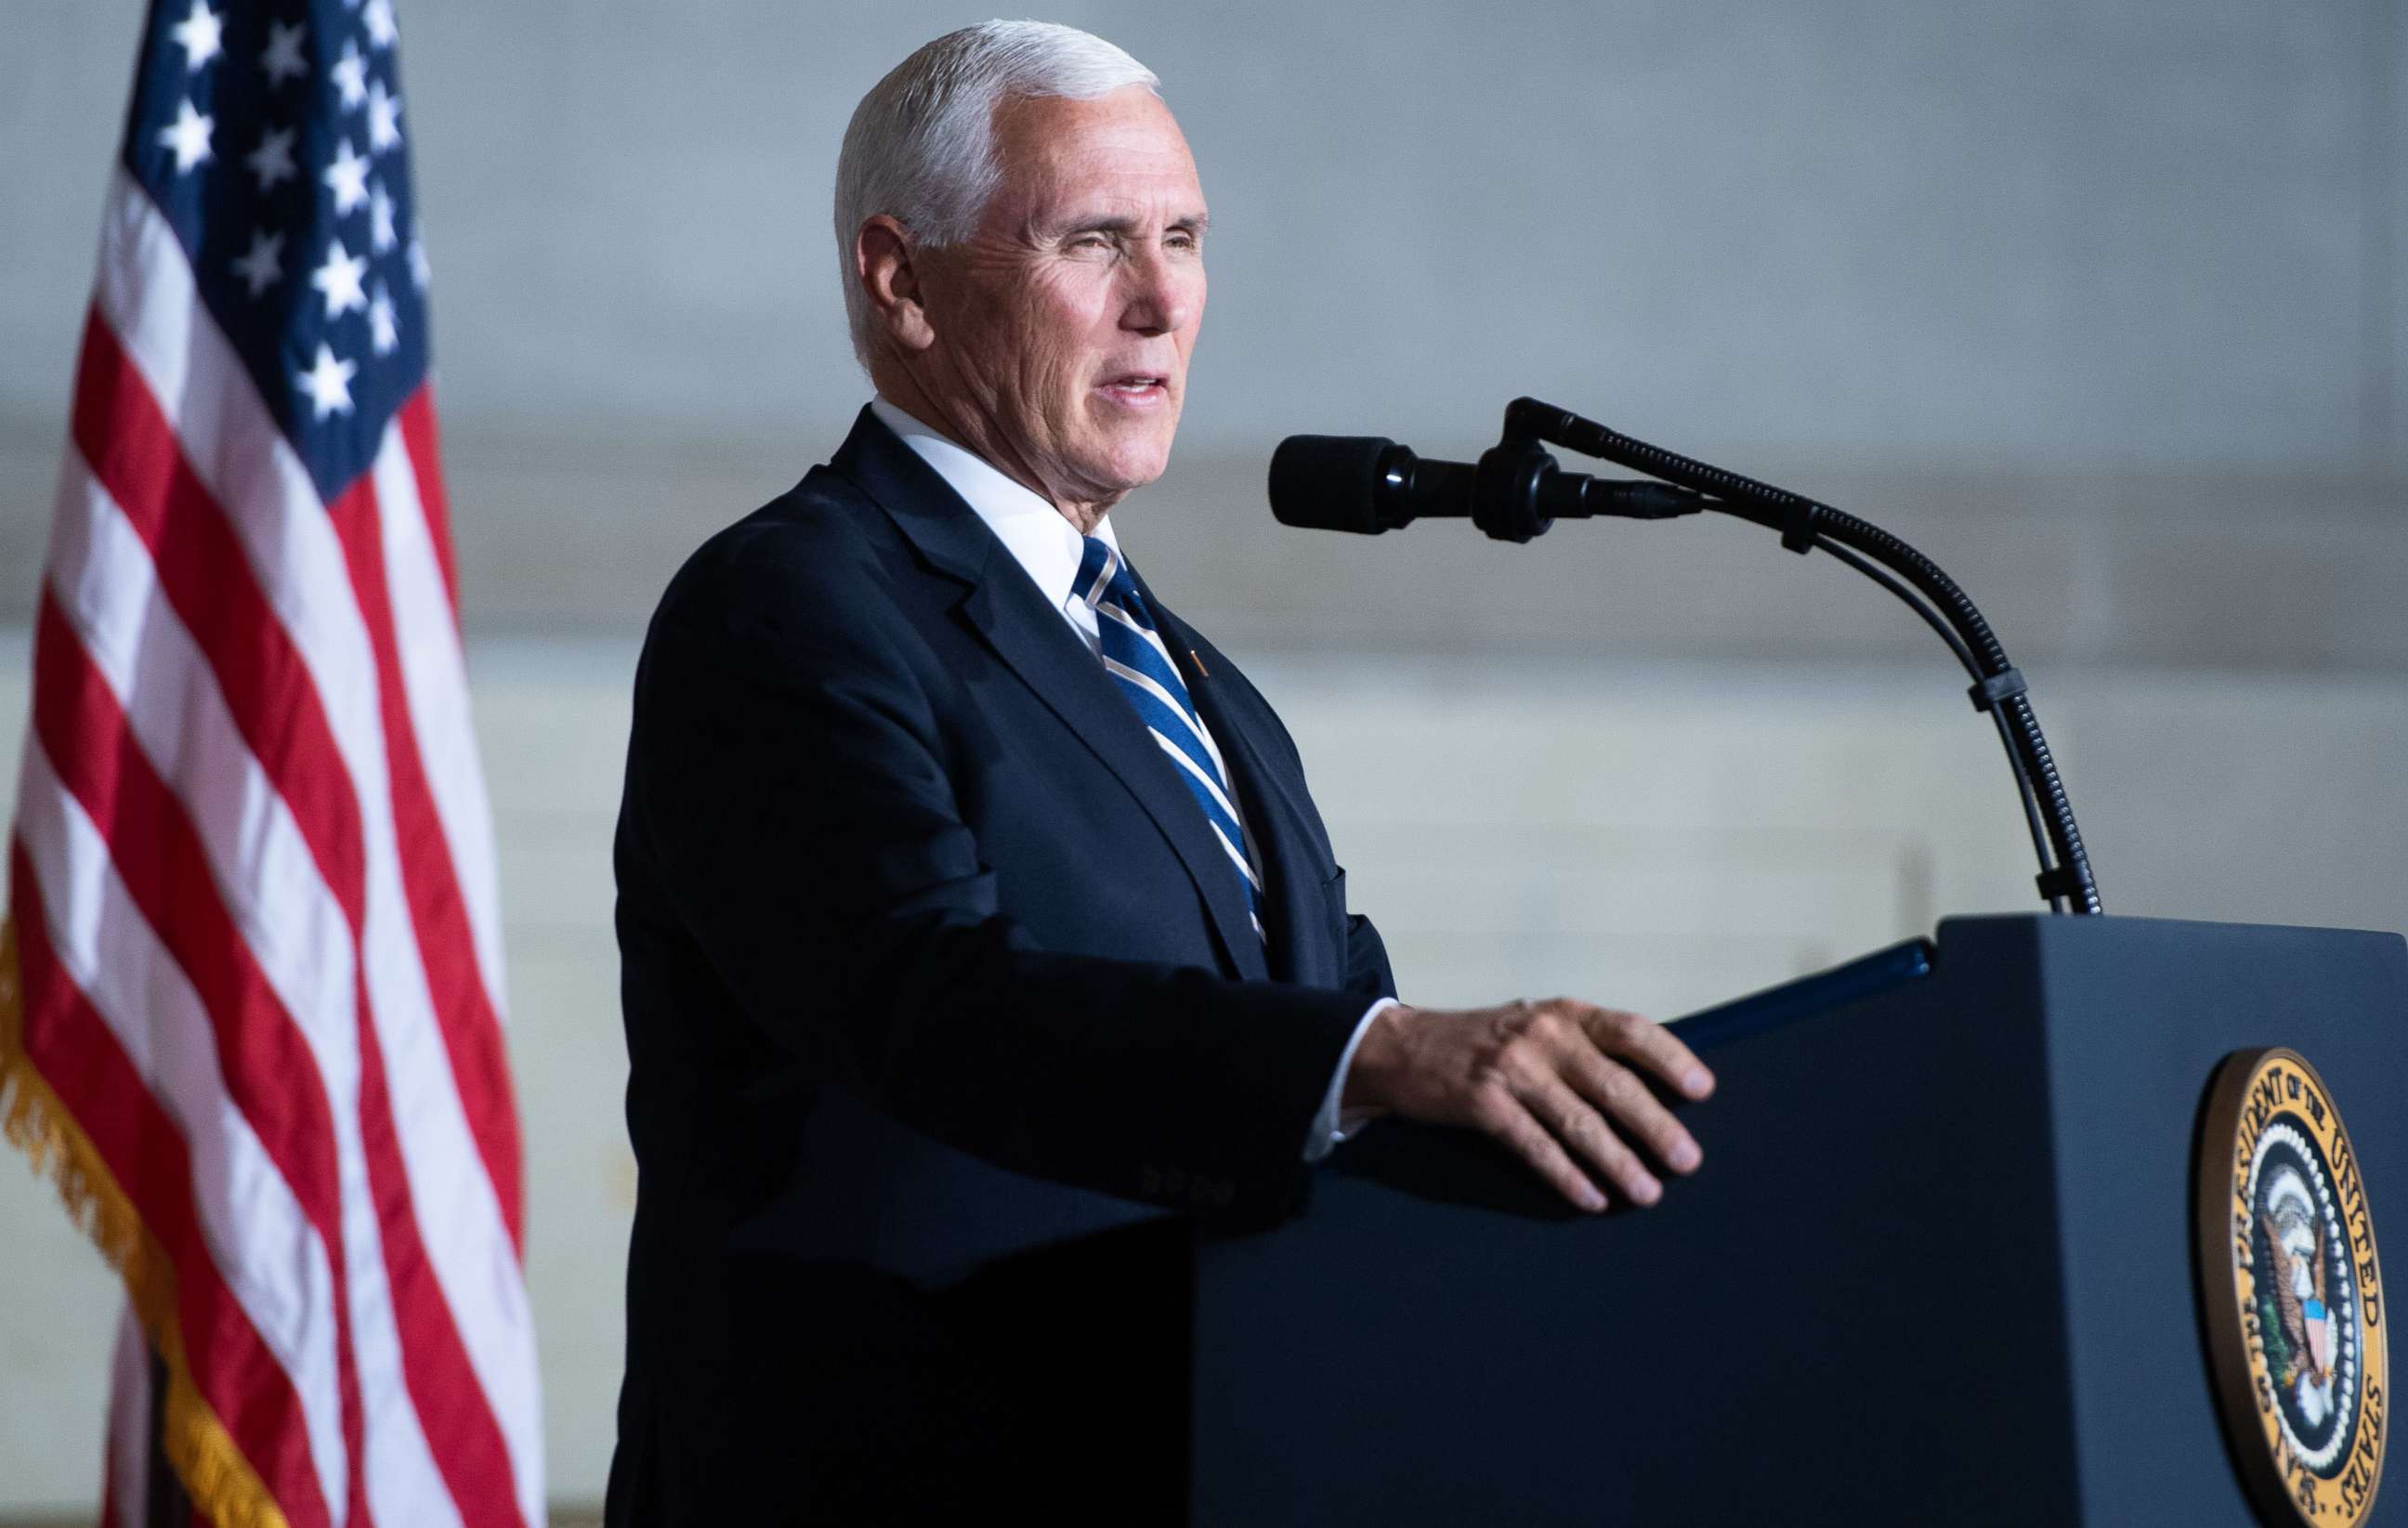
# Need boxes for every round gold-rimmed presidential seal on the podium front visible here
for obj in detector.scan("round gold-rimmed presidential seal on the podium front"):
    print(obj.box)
[2198,1049,2391,1528]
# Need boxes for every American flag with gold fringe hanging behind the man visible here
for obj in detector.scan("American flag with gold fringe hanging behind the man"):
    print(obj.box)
[0,0,544,1528]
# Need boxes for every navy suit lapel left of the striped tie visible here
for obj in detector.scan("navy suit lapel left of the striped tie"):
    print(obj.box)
[831,409,1269,979]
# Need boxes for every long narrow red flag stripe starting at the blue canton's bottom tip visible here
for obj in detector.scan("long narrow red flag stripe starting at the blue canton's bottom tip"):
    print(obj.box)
[328,474,525,1251]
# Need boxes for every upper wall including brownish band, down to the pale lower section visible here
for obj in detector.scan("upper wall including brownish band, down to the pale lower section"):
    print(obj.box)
[0,0,2408,669]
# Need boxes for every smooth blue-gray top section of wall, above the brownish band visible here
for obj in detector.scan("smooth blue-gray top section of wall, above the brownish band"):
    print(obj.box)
[0,0,2408,472]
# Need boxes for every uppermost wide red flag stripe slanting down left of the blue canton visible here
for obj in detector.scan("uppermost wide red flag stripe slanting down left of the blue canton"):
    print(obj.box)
[74,308,366,936]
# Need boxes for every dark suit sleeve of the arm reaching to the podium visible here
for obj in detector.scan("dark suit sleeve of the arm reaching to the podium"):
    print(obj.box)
[622,531,1387,1220]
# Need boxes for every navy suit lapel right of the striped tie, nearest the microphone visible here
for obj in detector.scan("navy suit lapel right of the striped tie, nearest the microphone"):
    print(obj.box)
[1132,568,1346,986]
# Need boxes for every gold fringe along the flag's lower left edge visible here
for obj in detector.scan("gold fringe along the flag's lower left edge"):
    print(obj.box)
[0,917,289,1528]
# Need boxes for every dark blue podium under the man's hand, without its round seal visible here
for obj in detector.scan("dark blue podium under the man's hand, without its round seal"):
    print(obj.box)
[1136,917,2408,1528]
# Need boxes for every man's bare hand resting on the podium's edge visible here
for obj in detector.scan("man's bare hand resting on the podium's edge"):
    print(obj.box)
[1341,999,1715,1210]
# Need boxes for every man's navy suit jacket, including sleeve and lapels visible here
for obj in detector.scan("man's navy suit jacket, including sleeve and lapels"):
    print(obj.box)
[611,409,1394,1523]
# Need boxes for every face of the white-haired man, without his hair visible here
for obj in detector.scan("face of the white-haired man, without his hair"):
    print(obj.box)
[920,86,1204,505]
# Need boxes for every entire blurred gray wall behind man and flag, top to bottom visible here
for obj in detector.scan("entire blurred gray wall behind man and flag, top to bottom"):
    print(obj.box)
[0,0,2408,1516]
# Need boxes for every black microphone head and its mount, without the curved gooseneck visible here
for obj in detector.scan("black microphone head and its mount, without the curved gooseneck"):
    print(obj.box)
[1272,436,1708,542]
